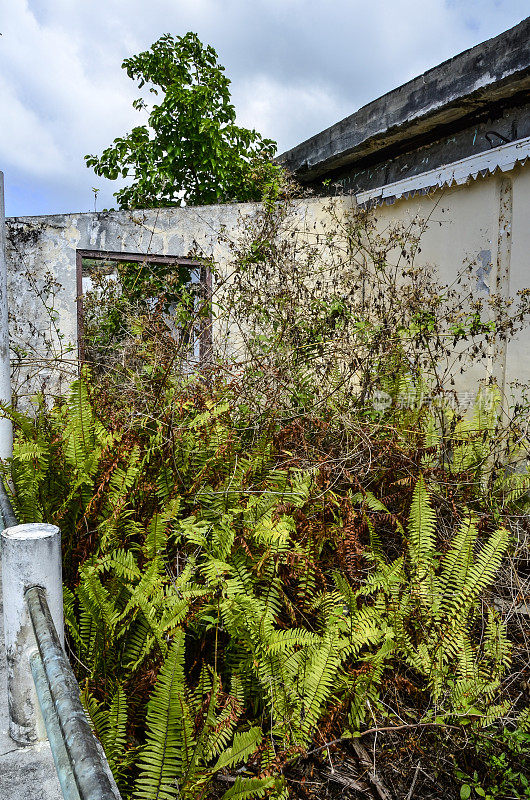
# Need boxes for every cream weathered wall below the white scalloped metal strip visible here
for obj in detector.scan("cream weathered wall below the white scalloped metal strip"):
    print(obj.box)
[374,165,530,410]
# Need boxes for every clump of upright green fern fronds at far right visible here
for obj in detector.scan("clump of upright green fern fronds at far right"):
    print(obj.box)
[350,477,509,724]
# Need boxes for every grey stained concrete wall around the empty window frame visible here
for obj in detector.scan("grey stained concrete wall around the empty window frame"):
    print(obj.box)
[6,199,334,402]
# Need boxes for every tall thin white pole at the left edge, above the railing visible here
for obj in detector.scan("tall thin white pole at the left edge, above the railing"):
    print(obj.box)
[0,172,13,461]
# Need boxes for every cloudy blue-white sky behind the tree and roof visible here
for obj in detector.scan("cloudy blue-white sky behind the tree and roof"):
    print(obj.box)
[0,0,530,216]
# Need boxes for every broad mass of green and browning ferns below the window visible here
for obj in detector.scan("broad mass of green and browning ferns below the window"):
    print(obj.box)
[9,368,525,800]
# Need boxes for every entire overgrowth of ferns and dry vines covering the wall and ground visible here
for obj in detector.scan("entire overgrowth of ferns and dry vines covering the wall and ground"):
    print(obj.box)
[6,195,530,800]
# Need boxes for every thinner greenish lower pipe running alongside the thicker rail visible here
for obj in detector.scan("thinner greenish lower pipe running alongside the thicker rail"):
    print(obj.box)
[29,651,81,800]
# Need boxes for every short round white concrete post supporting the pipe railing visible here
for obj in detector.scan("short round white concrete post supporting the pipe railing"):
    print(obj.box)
[0,522,64,744]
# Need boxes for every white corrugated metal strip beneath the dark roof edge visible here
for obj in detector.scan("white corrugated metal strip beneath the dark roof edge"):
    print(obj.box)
[356,136,530,206]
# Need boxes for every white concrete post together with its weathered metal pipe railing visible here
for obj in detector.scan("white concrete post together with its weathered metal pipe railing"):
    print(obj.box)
[0,488,120,800]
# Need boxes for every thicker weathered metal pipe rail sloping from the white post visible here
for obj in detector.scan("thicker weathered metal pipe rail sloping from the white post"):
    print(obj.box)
[25,586,120,800]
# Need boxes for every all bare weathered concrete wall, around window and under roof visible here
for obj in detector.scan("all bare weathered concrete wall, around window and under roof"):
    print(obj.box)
[7,164,530,410]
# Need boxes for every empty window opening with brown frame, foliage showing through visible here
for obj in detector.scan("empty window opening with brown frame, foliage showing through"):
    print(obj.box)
[77,250,211,371]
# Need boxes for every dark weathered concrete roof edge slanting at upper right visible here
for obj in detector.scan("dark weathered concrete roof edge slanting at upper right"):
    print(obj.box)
[276,17,530,182]
